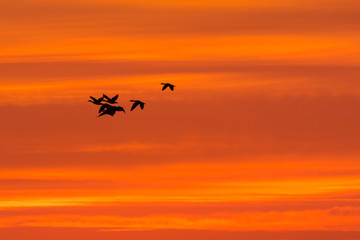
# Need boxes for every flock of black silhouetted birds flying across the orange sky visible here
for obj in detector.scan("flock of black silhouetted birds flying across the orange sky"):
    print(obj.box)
[89,83,175,117]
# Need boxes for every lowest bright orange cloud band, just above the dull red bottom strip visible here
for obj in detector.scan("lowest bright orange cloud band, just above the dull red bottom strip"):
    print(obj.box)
[0,208,360,231]
